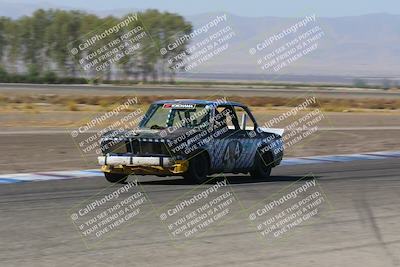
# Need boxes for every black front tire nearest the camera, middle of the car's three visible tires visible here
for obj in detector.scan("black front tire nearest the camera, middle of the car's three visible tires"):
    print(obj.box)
[183,151,210,184]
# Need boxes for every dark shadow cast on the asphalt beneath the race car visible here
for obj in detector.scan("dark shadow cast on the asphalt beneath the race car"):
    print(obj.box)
[140,175,319,185]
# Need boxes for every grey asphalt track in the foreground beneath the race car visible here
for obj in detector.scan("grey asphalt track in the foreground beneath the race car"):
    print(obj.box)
[0,158,400,266]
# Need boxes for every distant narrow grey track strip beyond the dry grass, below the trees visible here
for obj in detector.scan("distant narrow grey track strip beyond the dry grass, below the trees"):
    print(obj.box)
[0,83,400,99]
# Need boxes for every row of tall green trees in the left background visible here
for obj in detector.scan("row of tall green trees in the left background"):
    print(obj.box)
[0,9,192,83]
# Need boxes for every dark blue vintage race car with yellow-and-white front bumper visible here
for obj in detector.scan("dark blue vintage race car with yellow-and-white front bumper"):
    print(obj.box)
[98,99,284,183]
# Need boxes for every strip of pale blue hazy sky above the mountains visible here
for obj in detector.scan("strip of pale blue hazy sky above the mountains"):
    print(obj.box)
[0,0,400,17]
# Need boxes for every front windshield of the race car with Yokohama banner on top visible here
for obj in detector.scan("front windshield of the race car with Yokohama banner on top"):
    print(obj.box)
[140,103,210,129]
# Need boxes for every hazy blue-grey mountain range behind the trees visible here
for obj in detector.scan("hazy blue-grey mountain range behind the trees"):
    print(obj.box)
[0,1,400,79]
